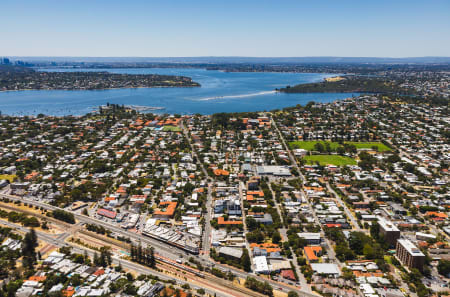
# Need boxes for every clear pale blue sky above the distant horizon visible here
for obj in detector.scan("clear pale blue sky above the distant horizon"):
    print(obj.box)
[0,0,450,57]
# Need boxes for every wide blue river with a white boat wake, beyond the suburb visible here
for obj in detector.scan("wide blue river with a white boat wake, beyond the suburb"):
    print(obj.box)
[0,68,356,115]
